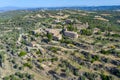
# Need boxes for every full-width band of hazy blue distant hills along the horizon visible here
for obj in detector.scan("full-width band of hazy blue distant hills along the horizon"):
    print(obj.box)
[0,6,120,12]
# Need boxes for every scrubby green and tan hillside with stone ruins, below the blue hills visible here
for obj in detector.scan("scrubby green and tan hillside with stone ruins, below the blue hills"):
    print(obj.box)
[0,7,120,80]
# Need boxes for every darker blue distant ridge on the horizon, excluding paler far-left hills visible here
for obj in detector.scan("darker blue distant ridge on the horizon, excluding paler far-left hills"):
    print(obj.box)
[23,6,120,11]
